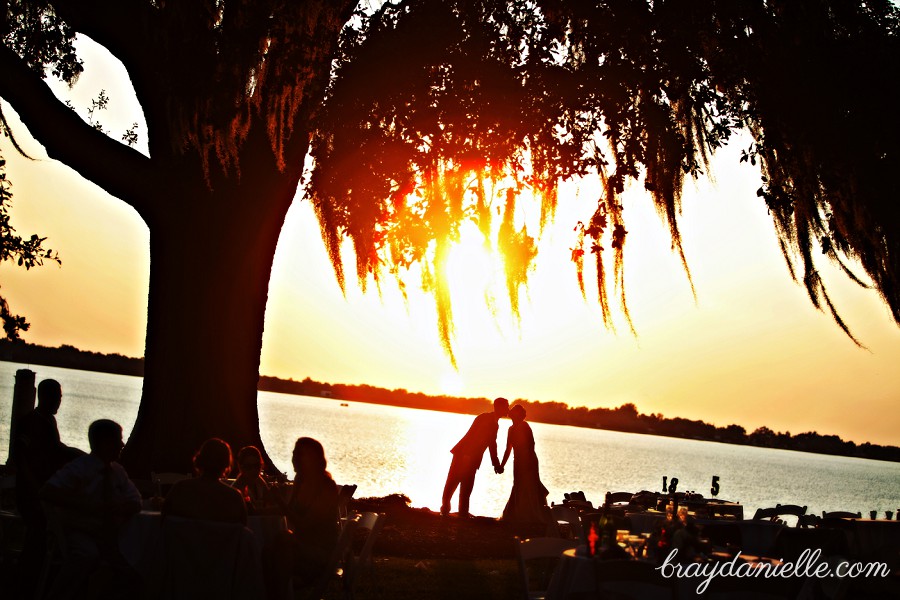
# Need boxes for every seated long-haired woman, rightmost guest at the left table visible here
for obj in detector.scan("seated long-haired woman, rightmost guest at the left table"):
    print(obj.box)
[263,437,340,598]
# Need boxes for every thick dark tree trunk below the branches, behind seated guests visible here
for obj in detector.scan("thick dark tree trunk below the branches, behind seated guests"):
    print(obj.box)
[122,157,297,476]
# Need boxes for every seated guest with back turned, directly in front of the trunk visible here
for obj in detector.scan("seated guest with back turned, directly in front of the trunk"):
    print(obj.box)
[162,438,247,524]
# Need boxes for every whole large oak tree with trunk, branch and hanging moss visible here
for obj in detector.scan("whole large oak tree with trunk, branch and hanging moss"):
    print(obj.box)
[0,0,900,473]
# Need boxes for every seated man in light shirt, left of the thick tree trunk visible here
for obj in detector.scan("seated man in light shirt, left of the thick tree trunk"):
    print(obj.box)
[40,419,141,598]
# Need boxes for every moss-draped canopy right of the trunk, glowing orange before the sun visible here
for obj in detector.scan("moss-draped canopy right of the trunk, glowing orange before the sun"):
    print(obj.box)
[307,0,900,356]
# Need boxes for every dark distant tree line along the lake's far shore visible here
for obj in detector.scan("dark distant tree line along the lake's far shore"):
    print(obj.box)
[0,340,900,462]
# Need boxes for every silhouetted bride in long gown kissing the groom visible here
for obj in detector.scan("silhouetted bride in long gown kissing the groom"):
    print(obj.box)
[500,404,550,526]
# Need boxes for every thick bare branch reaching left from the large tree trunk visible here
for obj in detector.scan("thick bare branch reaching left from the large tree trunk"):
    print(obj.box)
[0,45,153,215]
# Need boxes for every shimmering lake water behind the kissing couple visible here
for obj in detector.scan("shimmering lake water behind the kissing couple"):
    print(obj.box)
[0,362,900,517]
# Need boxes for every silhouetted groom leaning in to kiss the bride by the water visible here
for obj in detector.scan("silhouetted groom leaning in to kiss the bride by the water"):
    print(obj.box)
[441,398,509,517]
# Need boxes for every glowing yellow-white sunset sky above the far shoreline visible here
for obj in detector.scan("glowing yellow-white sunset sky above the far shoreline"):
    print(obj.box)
[0,41,900,445]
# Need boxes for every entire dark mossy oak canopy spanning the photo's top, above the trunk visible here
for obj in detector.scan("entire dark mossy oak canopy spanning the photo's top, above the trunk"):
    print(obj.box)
[0,0,900,356]
